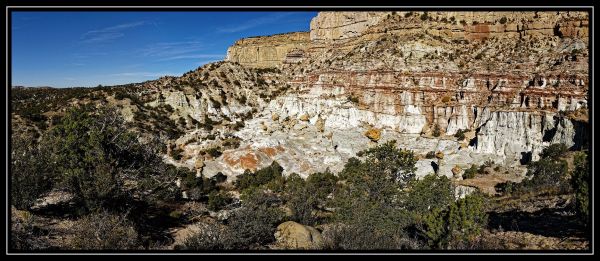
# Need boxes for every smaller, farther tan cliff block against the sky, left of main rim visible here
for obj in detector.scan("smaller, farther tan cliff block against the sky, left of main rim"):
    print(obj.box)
[226,32,309,68]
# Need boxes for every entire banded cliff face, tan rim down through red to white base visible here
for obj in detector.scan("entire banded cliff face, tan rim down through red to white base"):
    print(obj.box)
[175,12,589,181]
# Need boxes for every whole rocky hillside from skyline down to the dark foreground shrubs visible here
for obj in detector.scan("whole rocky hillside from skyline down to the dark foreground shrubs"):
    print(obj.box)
[11,11,591,249]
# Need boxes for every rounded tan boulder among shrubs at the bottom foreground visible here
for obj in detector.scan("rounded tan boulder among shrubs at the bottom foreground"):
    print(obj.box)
[275,221,323,249]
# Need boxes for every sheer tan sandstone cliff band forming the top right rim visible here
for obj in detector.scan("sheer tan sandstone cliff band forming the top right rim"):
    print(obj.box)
[310,11,589,42]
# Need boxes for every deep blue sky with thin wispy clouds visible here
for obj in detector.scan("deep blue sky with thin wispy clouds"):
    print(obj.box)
[11,11,316,87]
